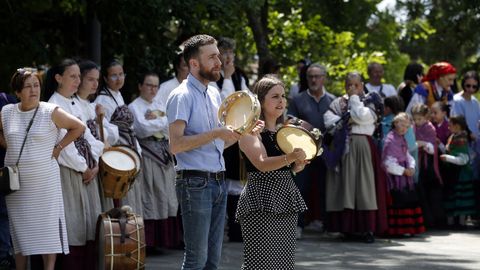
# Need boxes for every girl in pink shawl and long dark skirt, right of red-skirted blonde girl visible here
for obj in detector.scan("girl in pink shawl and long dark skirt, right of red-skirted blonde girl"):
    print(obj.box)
[412,104,445,228]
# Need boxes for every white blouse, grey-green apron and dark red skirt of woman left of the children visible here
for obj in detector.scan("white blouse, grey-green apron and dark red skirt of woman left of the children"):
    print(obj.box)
[324,95,387,237]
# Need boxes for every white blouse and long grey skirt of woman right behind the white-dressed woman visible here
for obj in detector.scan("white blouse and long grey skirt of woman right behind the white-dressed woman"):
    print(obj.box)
[49,92,103,269]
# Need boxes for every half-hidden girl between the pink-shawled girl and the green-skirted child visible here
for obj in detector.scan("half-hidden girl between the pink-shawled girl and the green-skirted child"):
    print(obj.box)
[431,101,450,153]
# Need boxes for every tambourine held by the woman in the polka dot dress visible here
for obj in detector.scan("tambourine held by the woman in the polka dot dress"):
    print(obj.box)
[276,118,323,160]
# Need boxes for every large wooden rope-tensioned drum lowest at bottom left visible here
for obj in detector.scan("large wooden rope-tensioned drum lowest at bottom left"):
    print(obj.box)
[96,213,145,270]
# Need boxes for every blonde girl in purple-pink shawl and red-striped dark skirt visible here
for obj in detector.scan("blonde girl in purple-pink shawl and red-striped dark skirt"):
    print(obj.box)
[382,112,425,236]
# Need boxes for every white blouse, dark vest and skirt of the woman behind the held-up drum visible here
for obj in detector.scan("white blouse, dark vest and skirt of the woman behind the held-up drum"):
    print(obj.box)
[94,88,143,216]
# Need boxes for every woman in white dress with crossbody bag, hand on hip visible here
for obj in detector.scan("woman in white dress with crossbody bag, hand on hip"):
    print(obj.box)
[0,68,85,270]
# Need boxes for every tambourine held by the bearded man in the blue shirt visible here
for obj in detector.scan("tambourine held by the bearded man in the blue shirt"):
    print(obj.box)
[218,90,261,134]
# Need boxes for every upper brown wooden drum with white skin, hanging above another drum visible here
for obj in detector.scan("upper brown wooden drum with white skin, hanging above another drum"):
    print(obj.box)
[99,146,138,199]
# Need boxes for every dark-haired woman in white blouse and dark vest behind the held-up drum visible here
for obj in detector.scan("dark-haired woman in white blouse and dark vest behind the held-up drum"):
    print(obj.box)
[94,59,143,213]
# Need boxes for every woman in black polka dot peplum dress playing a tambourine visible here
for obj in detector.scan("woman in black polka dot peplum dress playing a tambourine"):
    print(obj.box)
[236,76,308,270]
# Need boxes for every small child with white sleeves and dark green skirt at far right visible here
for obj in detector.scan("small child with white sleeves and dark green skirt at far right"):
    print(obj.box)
[440,115,475,228]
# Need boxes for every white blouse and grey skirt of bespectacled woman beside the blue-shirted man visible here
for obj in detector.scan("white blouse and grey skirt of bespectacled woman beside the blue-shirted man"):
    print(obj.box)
[128,97,181,247]
